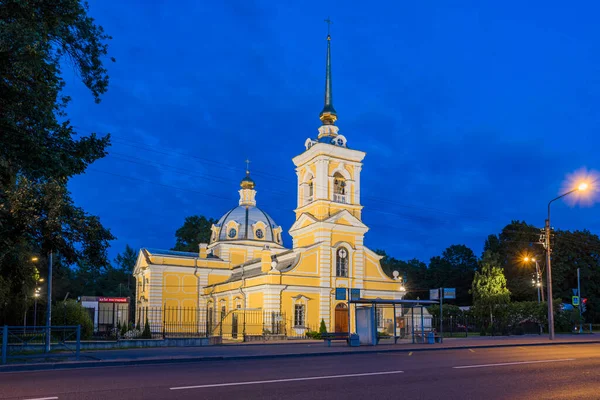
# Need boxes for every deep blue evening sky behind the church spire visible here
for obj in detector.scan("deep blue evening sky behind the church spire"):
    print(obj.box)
[65,0,600,260]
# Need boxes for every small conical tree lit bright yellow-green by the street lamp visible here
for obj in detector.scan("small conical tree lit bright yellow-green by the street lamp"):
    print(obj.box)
[471,251,510,325]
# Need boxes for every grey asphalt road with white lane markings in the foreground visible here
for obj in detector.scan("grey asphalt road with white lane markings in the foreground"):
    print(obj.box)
[0,344,600,400]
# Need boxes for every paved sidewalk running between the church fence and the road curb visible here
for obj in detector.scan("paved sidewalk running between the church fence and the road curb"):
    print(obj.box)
[0,335,600,372]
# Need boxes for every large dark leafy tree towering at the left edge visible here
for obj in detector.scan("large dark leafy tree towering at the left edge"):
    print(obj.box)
[0,0,113,321]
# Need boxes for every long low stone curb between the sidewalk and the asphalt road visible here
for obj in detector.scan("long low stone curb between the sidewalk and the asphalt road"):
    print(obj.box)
[0,340,600,374]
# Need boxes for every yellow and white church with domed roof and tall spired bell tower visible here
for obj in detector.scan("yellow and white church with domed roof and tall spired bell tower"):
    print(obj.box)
[134,35,405,339]
